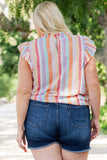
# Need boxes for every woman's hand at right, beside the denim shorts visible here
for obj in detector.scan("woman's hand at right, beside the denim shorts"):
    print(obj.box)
[90,118,100,141]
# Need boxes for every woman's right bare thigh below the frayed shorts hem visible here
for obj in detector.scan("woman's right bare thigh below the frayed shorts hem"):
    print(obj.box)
[61,148,89,160]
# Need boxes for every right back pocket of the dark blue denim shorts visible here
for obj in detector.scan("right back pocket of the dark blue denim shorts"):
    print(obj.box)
[66,104,90,128]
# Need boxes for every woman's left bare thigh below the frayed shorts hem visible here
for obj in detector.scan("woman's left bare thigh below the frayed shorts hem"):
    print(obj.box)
[31,143,62,160]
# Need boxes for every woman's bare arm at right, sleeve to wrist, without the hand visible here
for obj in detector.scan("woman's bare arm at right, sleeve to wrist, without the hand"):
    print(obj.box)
[85,57,101,119]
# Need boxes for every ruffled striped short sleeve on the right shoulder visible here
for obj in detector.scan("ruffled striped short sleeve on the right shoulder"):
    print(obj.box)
[84,36,96,65]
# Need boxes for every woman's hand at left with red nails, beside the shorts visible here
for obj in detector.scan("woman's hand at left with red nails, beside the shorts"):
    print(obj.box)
[16,129,27,152]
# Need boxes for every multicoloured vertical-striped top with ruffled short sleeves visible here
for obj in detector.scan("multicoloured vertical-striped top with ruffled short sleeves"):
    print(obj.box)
[18,32,96,105]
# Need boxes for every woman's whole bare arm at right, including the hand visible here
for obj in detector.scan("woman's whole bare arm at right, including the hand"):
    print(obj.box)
[85,57,101,140]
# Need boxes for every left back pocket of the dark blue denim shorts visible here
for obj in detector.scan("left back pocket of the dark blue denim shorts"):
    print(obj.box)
[26,102,49,127]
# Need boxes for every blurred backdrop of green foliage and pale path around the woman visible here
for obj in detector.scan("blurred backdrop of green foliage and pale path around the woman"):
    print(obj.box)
[0,0,107,160]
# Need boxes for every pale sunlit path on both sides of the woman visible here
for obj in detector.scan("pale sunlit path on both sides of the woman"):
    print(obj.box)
[0,103,107,160]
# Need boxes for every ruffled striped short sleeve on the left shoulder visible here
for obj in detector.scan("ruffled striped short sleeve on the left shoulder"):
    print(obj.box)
[17,42,33,72]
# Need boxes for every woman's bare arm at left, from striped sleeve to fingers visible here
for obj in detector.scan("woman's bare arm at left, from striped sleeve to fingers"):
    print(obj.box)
[16,55,32,149]
